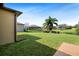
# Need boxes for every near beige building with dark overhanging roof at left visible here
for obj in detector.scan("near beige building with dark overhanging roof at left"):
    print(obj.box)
[0,3,22,45]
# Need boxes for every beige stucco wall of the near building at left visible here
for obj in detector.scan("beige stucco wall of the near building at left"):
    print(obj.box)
[0,9,14,45]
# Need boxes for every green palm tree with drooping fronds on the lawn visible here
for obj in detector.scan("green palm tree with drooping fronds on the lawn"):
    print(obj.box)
[43,16,58,32]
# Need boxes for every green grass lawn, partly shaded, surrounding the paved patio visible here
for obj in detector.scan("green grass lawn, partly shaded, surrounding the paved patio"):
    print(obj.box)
[0,31,79,56]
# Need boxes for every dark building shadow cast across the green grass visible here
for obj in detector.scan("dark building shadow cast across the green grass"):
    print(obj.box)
[0,34,56,56]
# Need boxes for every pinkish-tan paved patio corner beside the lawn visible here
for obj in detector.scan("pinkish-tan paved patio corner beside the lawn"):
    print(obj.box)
[54,43,79,56]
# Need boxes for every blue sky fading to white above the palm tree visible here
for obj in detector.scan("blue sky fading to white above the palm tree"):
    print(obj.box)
[5,3,79,26]
